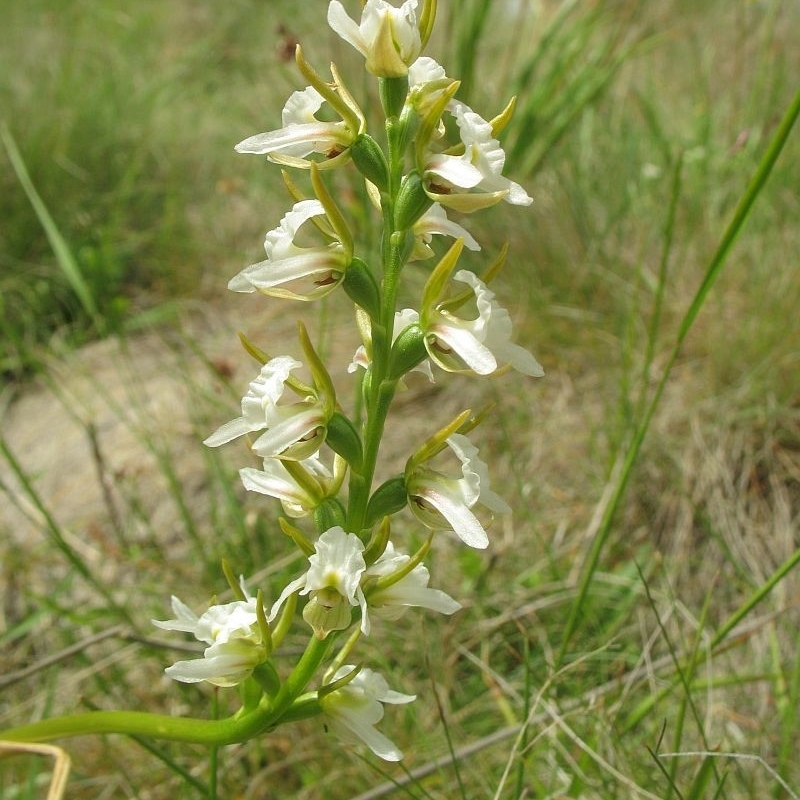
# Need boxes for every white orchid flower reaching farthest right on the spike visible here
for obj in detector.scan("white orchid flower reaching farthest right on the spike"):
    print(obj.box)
[422,269,544,378]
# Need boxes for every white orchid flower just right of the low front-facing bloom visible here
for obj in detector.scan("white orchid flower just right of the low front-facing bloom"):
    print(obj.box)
[365,542,461,621]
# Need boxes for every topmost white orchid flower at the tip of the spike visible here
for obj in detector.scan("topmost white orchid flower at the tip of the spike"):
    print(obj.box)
[328,0,422,78]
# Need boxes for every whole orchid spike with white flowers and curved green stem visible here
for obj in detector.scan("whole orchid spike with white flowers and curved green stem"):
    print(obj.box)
[5,0,543,780]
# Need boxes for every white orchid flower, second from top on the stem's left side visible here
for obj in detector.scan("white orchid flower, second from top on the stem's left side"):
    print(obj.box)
[228,200,352,300]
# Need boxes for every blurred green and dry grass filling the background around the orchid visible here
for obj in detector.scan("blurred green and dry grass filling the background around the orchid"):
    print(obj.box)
[0,0,800,800]
